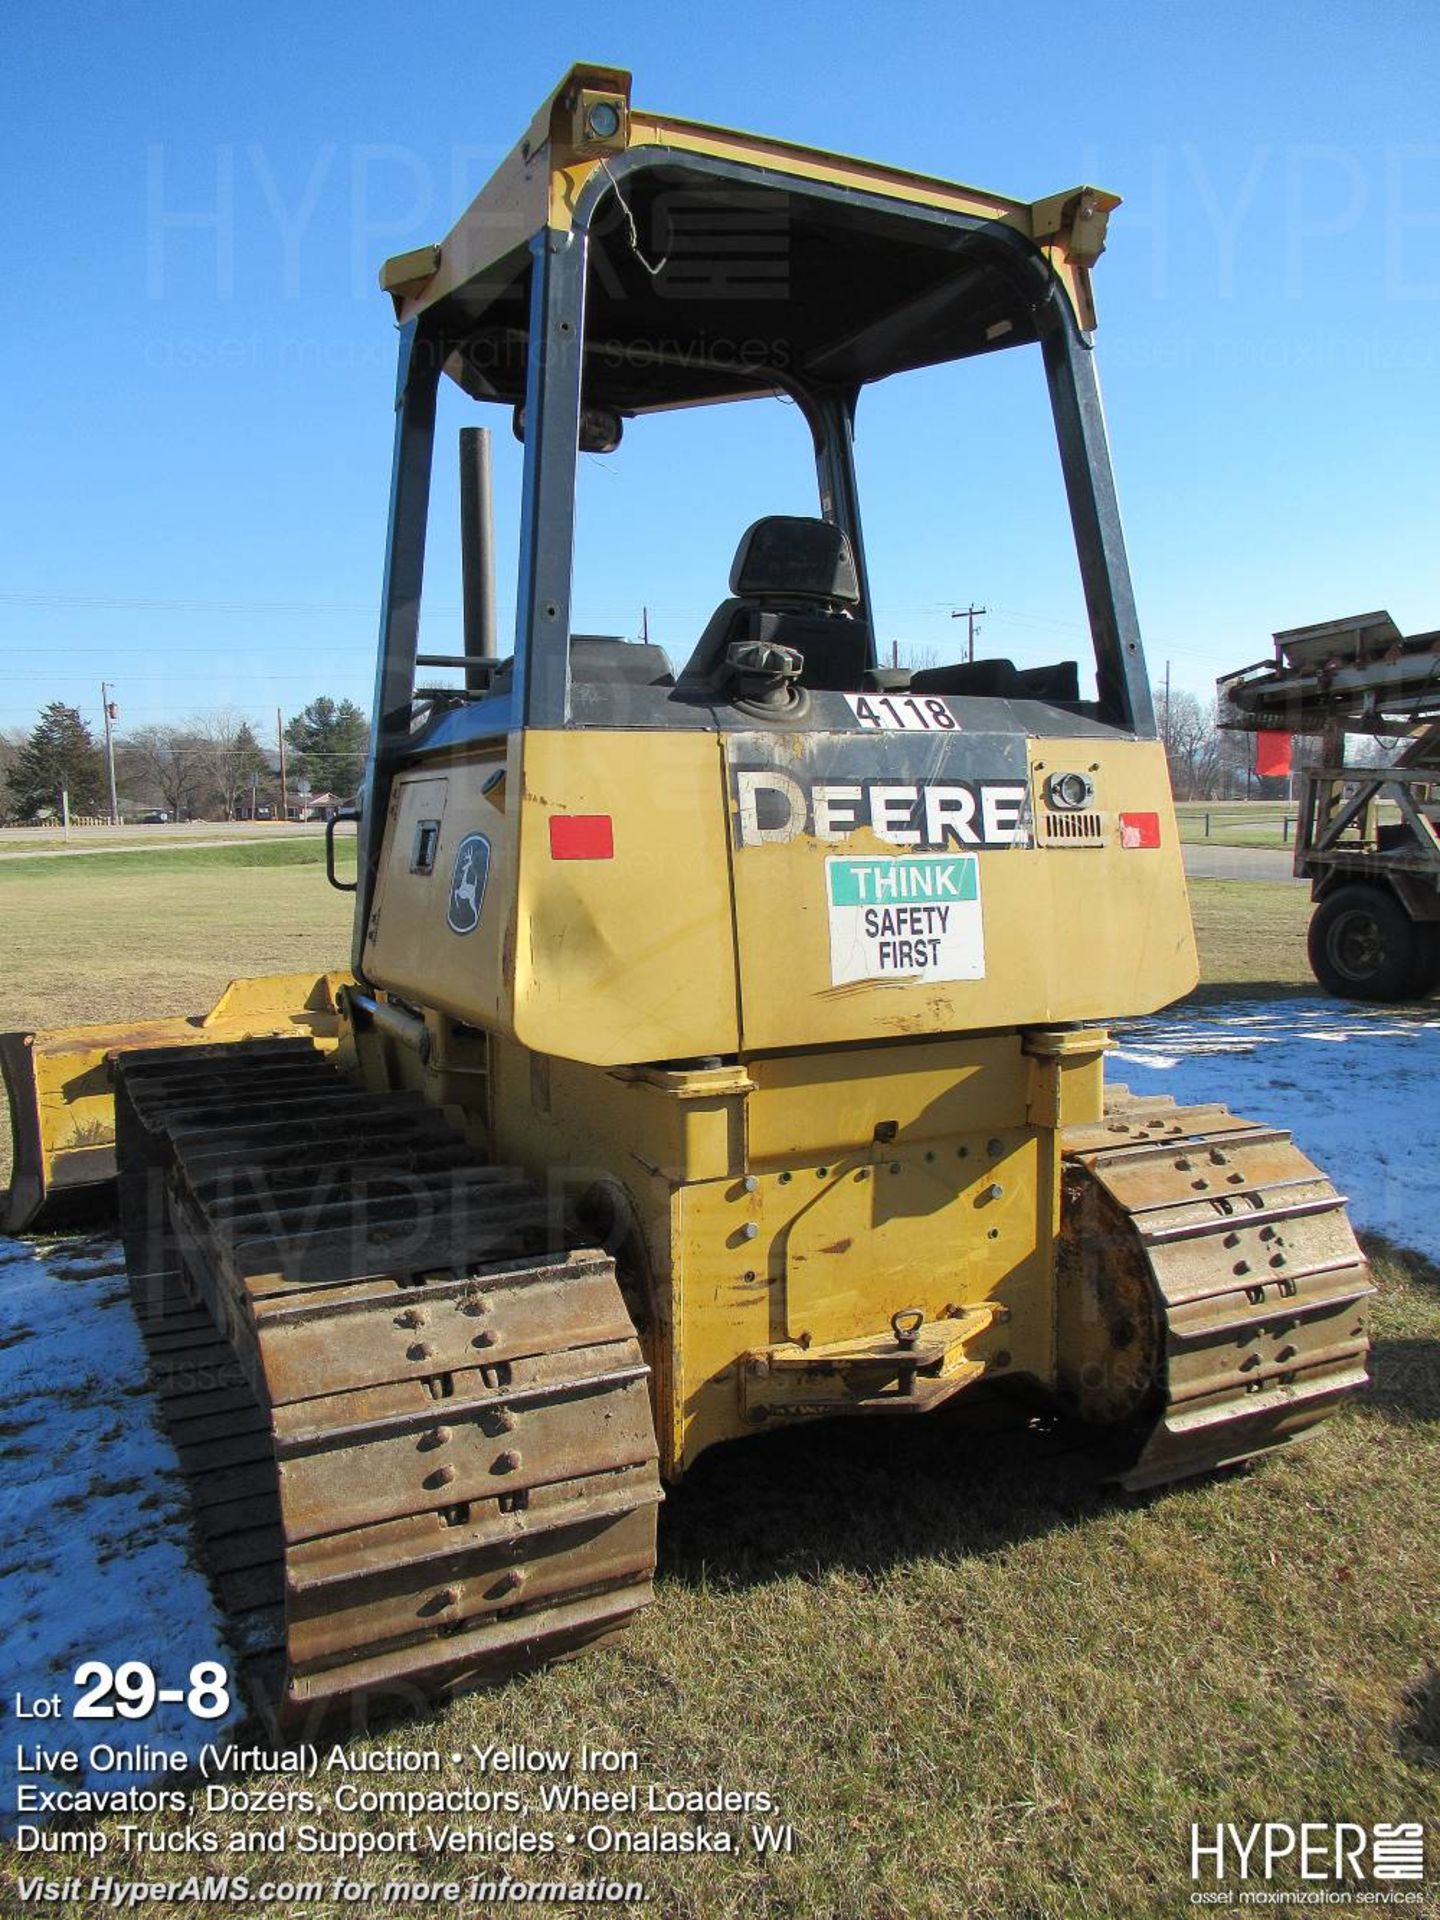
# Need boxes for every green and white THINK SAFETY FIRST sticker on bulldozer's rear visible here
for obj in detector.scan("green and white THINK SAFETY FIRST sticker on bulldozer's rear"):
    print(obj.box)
[826,854,985,987]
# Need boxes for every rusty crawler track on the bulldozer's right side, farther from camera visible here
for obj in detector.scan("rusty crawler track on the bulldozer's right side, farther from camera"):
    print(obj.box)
[1060,1087,1375,1488]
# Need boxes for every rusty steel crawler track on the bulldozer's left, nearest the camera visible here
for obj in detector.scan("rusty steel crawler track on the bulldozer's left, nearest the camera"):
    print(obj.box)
[117,1041,660,1730]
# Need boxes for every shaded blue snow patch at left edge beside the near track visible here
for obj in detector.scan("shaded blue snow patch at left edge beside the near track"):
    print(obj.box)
[0,1238,242,1834]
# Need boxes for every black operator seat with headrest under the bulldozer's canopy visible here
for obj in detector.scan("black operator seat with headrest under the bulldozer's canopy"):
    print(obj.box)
[680,513,870,693]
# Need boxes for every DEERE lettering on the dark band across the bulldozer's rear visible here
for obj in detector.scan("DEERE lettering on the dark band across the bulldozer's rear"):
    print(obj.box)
[735,768,1031,847]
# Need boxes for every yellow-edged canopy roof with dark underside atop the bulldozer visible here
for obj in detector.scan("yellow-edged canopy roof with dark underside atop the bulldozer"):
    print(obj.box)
[380,65,1117,411]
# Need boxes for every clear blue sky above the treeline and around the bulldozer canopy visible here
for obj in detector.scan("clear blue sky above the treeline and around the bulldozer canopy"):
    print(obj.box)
[0,0,1440,726]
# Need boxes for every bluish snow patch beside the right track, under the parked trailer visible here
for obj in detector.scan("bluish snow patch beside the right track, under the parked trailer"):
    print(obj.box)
[1106,998,1440,1260]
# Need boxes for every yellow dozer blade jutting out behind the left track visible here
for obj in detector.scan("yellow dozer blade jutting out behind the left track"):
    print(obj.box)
[0,973,349,1233]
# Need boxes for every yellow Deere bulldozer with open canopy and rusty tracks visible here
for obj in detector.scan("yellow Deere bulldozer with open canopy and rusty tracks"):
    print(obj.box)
[4,65,1371,1722]
